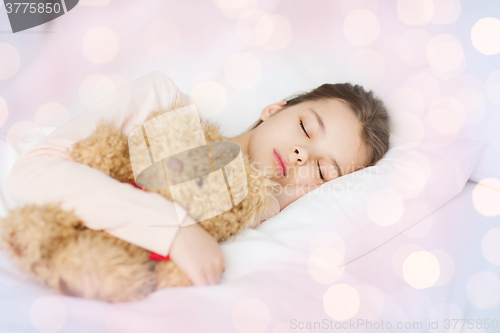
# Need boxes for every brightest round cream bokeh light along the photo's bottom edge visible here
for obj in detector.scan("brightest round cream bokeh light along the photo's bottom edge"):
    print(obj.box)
[323,283,361,321]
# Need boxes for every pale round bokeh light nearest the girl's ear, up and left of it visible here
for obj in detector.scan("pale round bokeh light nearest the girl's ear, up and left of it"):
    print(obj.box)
[224,52,262,89]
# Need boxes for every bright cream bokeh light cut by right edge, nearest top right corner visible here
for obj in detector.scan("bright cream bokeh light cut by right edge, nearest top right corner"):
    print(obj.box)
[470,17,500,55]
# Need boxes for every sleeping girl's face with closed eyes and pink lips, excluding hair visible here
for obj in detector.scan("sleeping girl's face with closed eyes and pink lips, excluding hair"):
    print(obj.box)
[247,99,368,210]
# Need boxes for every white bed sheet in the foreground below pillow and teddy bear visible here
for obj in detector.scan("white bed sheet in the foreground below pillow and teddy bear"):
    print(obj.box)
[0,182,500,333]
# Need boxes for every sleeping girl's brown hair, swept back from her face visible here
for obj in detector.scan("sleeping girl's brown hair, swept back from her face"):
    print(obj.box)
[247,83,390,166]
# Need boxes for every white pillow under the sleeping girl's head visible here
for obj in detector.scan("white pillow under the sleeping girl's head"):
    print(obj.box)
[257,141,485,263]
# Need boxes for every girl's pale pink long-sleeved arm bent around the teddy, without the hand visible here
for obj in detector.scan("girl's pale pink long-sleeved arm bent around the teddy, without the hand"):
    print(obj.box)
[7,72,190,256]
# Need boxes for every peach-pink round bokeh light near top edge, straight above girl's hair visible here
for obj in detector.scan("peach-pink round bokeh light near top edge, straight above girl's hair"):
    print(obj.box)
[344,9,380,46]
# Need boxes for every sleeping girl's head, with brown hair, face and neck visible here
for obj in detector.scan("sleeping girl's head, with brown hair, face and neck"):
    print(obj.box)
[226,83,389,210]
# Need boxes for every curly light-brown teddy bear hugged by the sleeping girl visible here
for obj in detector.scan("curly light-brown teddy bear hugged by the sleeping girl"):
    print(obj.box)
[0,98,279,303]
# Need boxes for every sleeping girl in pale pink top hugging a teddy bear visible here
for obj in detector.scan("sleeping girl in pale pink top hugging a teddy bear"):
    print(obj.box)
[7,72,389,285]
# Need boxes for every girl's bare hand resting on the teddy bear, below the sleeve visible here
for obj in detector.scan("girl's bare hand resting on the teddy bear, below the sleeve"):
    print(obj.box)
[169,215,224,286]
